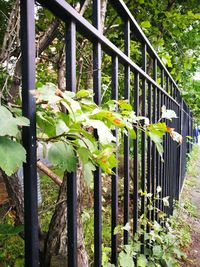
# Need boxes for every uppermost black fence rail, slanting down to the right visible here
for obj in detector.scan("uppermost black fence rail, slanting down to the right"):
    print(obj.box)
[110,0,180,91]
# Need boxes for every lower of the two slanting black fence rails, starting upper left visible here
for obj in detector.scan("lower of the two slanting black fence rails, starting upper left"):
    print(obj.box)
[37,0,180,106]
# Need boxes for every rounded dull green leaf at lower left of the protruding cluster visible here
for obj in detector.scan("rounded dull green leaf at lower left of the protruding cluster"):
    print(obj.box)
[48,141,77,172]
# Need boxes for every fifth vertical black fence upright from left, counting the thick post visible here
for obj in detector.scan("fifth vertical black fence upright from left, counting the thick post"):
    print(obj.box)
[124,18,130,245]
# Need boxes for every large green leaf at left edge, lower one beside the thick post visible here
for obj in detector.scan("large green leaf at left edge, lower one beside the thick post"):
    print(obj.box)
[0,137,26,176]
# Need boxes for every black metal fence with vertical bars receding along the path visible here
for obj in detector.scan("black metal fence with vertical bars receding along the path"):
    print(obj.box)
[21,0,192,267]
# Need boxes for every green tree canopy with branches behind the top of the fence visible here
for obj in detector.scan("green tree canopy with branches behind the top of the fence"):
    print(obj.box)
[0,0,200,116]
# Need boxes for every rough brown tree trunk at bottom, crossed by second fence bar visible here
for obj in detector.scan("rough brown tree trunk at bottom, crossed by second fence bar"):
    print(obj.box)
[44,168,88,267]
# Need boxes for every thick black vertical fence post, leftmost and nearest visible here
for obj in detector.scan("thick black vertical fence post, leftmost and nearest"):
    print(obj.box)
[21,0,39,267]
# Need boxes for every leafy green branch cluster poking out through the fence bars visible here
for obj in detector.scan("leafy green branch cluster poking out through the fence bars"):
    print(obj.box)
[35,84,182,184]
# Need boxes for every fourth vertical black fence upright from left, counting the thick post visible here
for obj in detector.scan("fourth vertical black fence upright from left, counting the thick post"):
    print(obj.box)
[111,56,118,265]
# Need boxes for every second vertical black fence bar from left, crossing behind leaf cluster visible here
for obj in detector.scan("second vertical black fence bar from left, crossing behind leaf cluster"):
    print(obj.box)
[66,21,77,267]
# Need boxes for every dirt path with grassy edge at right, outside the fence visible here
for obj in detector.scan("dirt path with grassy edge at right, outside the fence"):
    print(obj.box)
[181,146,200,267]
